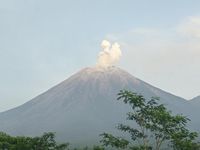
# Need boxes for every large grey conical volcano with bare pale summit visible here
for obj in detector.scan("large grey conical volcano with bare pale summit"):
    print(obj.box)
[0,67,198,144]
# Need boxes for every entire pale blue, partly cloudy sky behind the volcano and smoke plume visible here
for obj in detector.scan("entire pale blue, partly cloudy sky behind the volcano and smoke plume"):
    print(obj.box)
[0,0,200,111]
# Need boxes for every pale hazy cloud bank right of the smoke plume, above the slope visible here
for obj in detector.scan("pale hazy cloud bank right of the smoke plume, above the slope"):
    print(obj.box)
[106,16,200,99]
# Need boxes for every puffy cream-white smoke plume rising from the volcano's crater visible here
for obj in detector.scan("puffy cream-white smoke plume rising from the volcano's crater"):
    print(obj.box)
[97,40,122,67]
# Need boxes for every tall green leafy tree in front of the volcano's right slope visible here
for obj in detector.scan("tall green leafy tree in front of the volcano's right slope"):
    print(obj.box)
[100,90,200,150]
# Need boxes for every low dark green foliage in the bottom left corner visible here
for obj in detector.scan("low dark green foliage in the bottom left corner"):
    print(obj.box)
[0,132,69,150]
